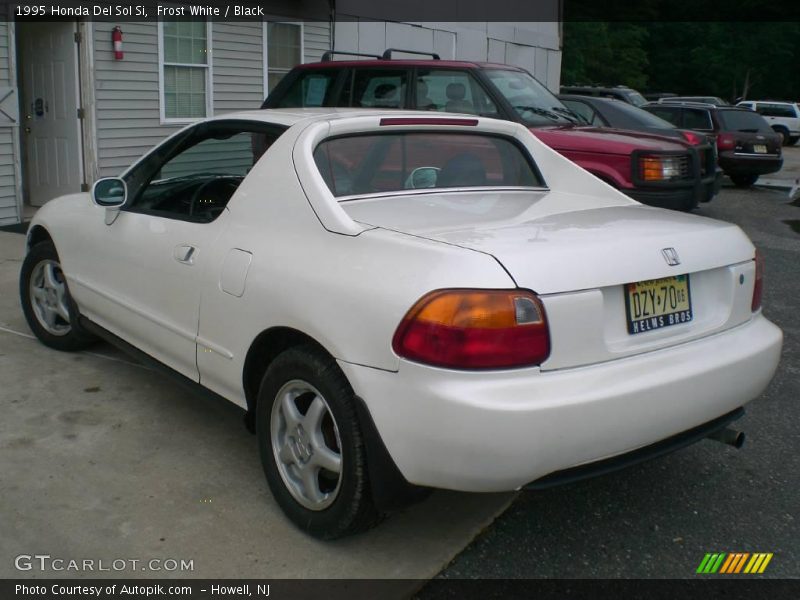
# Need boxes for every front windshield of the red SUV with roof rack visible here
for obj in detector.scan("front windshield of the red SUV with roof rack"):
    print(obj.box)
[484,70,578,126]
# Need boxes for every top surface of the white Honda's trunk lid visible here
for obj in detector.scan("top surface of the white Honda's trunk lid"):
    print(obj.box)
[341,190,754,294]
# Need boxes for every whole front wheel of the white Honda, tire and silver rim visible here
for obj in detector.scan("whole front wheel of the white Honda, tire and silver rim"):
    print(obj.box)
[19,242,96,352]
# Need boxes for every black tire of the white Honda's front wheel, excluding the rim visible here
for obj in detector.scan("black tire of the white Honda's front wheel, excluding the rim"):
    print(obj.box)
[19,241,97,352]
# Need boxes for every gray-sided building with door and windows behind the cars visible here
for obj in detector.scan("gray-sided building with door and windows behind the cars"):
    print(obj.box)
[0,17,561,225]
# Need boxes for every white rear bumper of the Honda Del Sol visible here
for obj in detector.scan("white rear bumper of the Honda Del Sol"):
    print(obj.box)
[340,314,783,492]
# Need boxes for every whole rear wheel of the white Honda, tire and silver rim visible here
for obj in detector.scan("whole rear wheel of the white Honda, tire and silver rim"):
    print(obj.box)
[256,346,380,540]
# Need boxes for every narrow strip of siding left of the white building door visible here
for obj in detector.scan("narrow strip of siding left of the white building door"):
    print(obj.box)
[0,21,21,225]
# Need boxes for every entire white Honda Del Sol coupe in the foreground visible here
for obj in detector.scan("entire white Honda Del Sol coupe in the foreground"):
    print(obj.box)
[20,109,782,538]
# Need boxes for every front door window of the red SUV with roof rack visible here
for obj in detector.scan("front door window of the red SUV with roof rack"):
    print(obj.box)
[416,69,497,117]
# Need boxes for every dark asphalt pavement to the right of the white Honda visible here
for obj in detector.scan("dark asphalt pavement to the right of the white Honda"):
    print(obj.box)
[428,147,800,580]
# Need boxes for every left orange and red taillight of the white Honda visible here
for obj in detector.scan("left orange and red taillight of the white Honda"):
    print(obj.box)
[392,289,550,369]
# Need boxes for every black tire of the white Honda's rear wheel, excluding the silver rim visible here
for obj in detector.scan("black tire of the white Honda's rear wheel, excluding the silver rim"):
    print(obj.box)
[256,346,381,540]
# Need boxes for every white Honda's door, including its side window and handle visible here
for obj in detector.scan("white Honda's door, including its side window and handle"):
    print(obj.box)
[71,121,276,381]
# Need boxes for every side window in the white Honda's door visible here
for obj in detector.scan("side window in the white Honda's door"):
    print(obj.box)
[125,123,280,223]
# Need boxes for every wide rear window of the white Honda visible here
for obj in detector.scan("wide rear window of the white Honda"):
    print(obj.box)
[314,132,543,197]
